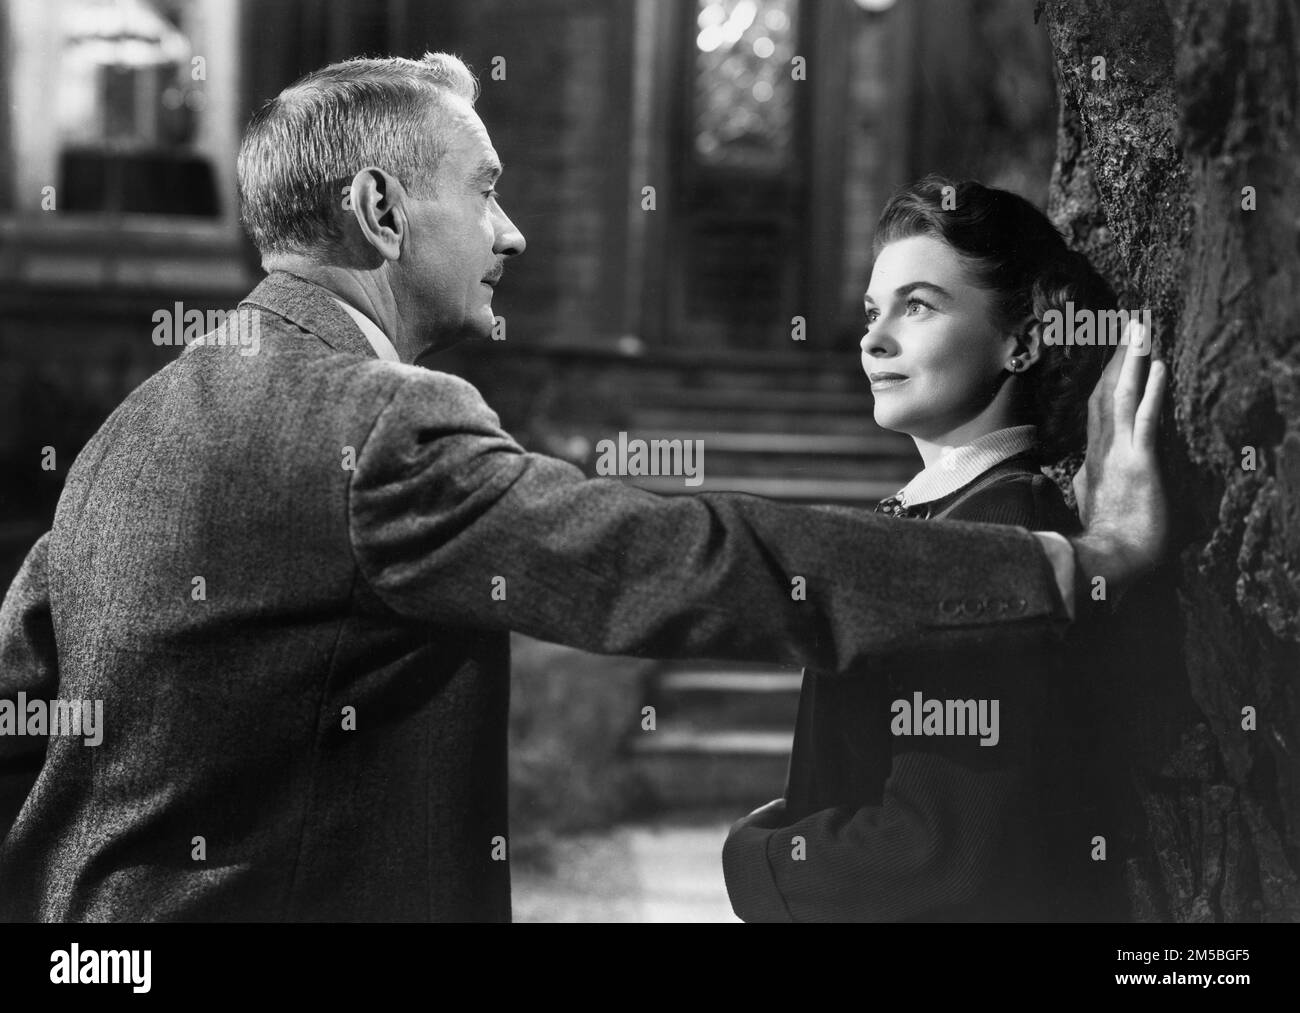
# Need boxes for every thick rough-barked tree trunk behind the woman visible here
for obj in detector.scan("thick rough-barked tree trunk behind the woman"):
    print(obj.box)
[1035,0,1300,922]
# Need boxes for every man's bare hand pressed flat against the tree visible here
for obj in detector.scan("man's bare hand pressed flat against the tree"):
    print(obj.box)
[1073,322,1169,601]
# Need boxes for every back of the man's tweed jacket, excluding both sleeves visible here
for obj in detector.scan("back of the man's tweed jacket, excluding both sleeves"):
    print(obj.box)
[0,280,510,921]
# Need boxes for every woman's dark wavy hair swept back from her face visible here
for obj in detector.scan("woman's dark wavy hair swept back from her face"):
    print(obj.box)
[875,176,1115,464]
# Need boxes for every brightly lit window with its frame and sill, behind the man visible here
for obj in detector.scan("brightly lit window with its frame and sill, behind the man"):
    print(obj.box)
[0,0,246,286]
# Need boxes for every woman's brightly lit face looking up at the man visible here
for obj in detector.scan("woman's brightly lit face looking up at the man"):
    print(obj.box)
[862,235,1015,442]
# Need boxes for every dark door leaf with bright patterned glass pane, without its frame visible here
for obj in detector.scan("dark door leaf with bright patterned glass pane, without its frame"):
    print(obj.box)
[672,0,815,349]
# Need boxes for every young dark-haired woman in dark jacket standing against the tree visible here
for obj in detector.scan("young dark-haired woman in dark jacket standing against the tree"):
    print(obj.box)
[723,177,1123,921]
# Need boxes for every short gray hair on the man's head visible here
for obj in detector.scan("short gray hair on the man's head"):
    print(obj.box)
[238,53,478,255]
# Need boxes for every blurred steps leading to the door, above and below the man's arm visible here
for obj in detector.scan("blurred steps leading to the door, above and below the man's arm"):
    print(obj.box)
[564,356,919,811]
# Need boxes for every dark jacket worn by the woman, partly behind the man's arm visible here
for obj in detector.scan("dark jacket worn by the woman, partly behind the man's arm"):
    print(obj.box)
[724,458,1123,921]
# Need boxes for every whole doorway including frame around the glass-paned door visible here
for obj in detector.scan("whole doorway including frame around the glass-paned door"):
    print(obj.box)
[641,0,849,352]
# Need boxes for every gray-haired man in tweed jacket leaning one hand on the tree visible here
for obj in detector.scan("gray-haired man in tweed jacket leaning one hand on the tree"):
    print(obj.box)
[0,55,1166,921]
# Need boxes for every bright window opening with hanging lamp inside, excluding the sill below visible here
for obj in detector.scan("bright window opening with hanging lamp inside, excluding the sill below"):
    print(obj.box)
[5,0,235,218]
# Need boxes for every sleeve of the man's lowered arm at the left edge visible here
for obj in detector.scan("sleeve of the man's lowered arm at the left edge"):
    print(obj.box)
[0,533,59,841]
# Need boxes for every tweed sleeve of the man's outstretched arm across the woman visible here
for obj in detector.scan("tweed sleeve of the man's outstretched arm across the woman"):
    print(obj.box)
[348,364,1067,672]
